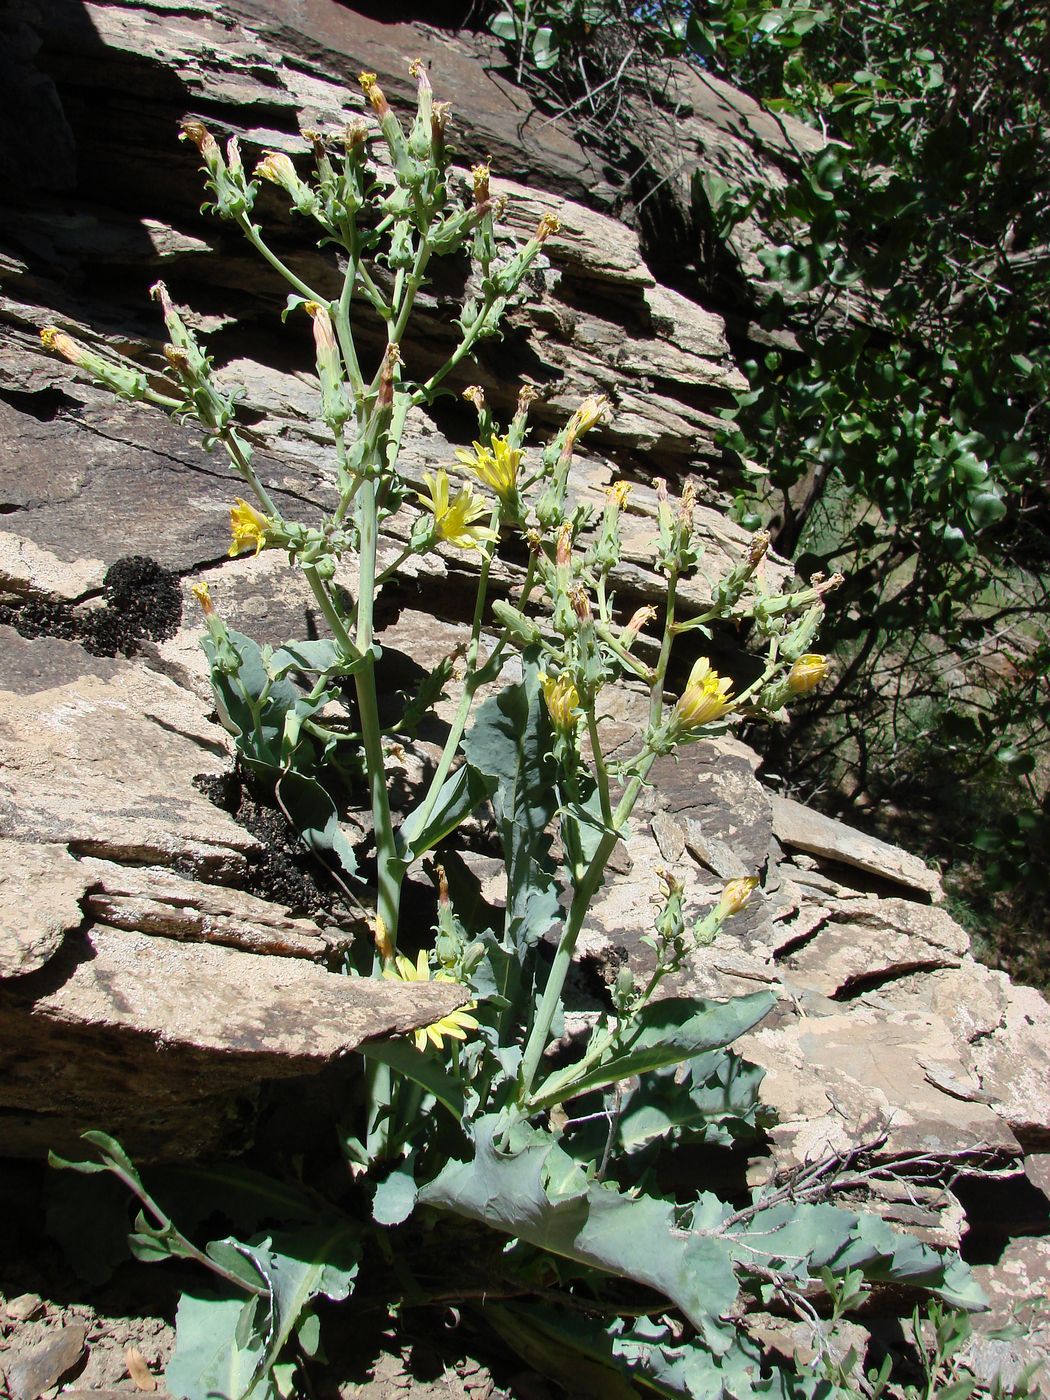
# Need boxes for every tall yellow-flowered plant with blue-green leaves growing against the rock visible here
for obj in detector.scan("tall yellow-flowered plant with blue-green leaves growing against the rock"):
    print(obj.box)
[43,63,974,1400]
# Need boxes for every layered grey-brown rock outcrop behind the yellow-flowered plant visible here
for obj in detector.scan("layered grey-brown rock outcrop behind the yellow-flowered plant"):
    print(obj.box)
[0,0,1050,1377]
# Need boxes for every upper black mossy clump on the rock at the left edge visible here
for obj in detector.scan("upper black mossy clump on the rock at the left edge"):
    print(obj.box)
[0,554,182,657]
